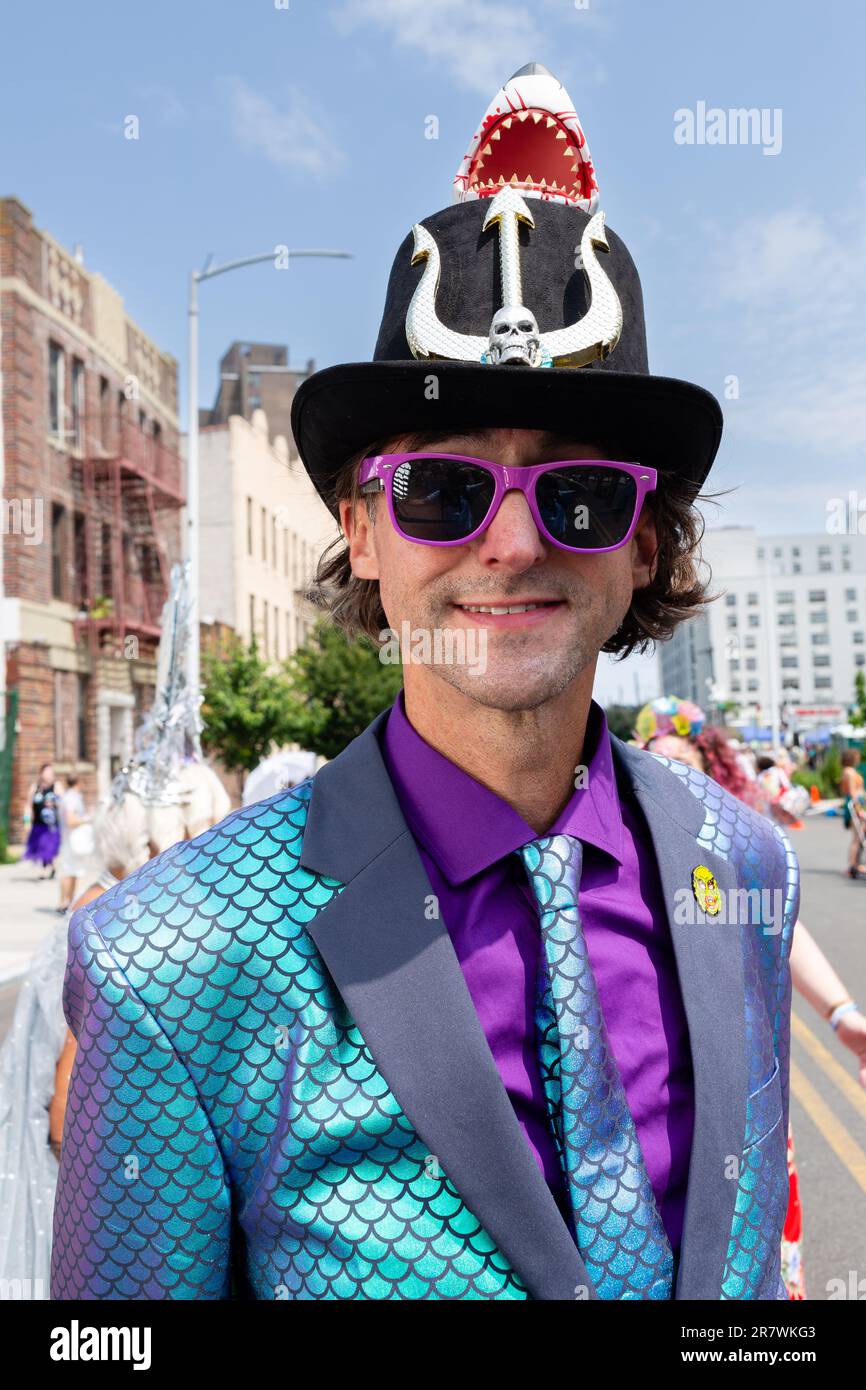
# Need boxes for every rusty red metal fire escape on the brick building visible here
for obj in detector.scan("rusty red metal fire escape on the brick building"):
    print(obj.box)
[75,410,185,659]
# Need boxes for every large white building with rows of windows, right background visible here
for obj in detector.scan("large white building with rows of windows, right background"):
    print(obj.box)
[660,527,866,726]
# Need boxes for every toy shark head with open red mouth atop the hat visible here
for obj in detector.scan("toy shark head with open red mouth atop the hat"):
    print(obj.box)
[455,63,599,214]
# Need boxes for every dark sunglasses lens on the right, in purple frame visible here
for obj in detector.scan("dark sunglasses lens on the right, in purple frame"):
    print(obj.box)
[535,466,638,550]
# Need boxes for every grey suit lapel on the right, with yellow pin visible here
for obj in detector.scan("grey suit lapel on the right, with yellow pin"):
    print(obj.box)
[612,738,748,1300]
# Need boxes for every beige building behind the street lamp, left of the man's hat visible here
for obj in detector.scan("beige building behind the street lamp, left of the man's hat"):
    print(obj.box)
[199,410,336,662]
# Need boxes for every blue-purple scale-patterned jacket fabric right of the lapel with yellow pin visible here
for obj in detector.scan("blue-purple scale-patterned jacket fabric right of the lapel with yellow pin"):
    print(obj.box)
[653,755,799,1300]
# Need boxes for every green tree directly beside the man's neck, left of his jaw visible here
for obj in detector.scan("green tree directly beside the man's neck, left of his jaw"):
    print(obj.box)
[286,620,403,758]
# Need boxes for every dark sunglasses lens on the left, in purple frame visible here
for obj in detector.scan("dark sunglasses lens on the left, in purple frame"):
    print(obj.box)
[393,459,495,541]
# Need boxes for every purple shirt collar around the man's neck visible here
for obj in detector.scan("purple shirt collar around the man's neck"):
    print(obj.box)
[382,691,623,884]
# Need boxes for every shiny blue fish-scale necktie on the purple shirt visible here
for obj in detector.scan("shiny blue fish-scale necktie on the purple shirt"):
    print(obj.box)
[518,834,674,1298]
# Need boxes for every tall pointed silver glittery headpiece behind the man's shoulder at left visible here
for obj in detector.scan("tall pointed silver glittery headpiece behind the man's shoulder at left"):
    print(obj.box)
[110,560,203,806]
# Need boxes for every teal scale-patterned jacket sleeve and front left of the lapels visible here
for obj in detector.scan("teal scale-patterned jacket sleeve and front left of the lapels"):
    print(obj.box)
[51,783,528,1300]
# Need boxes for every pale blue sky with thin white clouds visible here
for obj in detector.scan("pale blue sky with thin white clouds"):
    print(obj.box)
[0,0,866,698]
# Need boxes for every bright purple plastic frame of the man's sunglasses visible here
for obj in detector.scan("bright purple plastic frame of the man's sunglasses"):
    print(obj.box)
[359,449,657,555]
